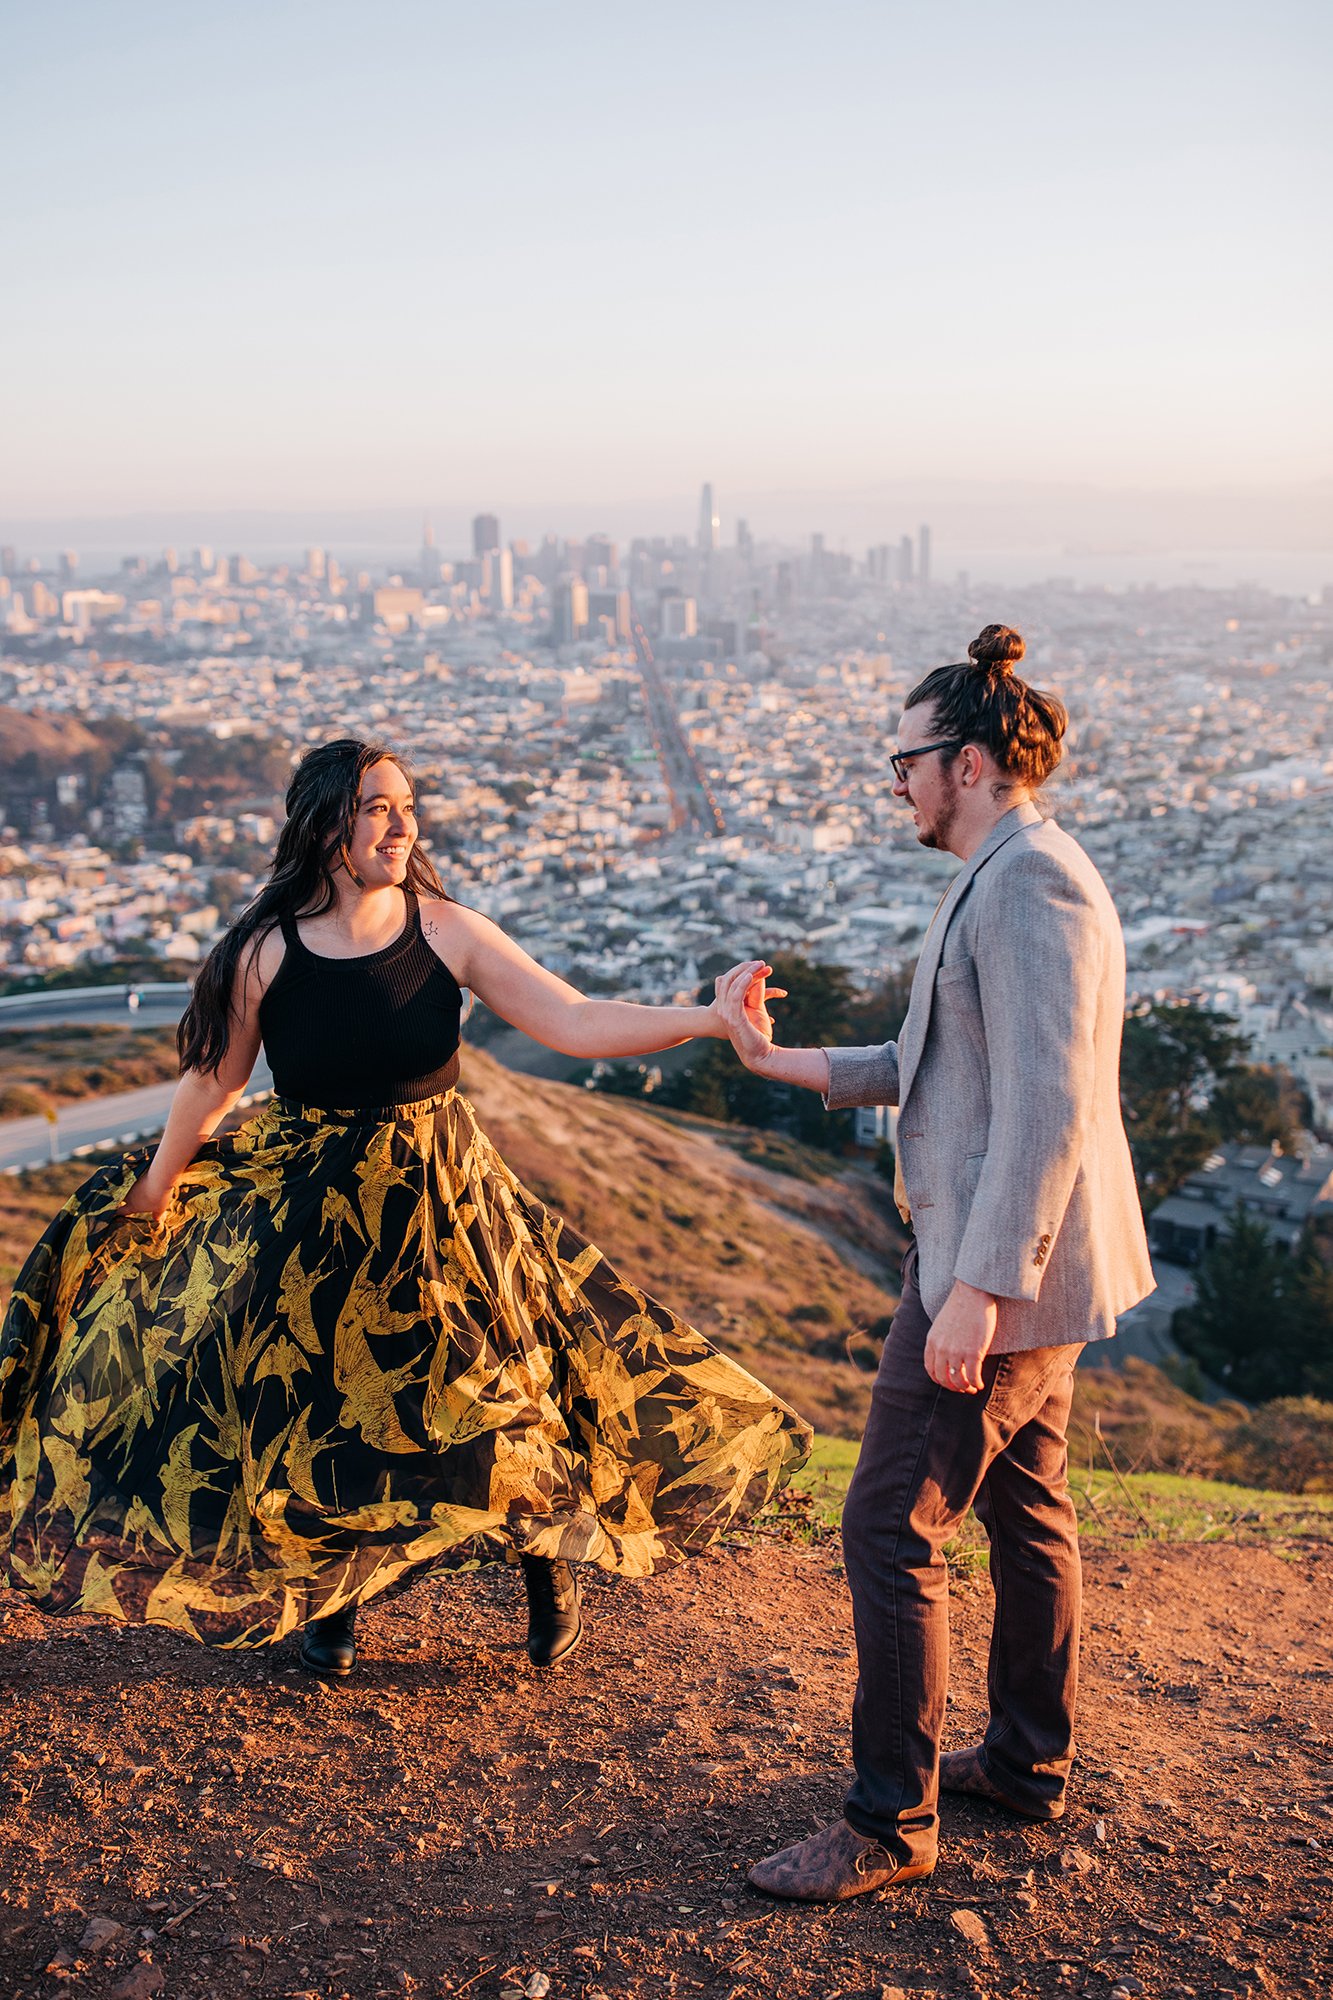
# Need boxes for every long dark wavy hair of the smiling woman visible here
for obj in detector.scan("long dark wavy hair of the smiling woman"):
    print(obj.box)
[176,736,444,1074]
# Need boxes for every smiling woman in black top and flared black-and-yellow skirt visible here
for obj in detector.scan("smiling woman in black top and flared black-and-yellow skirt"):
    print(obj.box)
[0,740,809,1672]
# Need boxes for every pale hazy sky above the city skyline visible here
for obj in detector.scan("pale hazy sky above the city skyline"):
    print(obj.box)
[0,0,1333,518]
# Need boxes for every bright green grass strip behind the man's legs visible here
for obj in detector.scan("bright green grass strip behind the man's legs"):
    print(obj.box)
[779,1438,1333,1570]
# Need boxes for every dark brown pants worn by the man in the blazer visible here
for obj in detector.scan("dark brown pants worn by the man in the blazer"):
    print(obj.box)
[843,1244,1083,1862]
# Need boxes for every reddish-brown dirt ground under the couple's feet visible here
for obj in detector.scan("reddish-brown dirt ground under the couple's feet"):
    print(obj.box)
[0,1536,1333,2000]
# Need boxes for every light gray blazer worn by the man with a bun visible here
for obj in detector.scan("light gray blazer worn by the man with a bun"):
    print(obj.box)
[825,804,1153,1354]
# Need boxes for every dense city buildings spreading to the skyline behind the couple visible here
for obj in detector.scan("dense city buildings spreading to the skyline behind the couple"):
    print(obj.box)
[0,488,1333,1128]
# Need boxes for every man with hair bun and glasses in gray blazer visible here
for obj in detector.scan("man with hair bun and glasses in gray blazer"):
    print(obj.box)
[719,626,1153,1902]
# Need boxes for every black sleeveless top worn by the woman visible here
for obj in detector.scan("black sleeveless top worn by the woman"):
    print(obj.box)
[258,890,462,1110]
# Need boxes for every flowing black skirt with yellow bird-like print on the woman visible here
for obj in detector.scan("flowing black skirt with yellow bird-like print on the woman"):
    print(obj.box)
[0,1090,811,1646]
